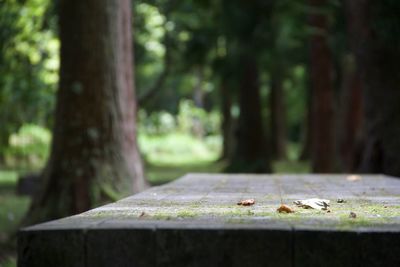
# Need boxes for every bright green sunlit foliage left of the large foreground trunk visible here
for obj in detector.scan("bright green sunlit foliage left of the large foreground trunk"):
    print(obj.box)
[0,0,59,153]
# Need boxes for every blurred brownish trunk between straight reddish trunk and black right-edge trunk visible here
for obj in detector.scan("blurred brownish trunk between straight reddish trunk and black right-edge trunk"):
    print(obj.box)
[330,2,363,173]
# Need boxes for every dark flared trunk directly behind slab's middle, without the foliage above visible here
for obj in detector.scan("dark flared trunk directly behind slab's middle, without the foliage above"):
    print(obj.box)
[228,54,271,173]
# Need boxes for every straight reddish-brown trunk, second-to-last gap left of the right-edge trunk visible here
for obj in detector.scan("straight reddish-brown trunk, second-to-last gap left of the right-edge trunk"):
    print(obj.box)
[310,0,335,173]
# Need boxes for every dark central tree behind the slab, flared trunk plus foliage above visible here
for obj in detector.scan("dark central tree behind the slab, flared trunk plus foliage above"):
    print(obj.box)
[222,1,271,173]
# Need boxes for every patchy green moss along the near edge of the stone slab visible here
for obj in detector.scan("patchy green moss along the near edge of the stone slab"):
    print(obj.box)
[79,200,400,230]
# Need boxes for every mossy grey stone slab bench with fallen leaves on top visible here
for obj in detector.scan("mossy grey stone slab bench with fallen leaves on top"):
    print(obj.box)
[18,174,400,267]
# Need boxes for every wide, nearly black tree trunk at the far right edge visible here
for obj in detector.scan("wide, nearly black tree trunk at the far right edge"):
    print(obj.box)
[346,0,400,176]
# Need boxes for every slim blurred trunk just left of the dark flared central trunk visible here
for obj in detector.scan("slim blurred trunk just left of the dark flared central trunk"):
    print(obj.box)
[219,78,234,160]
